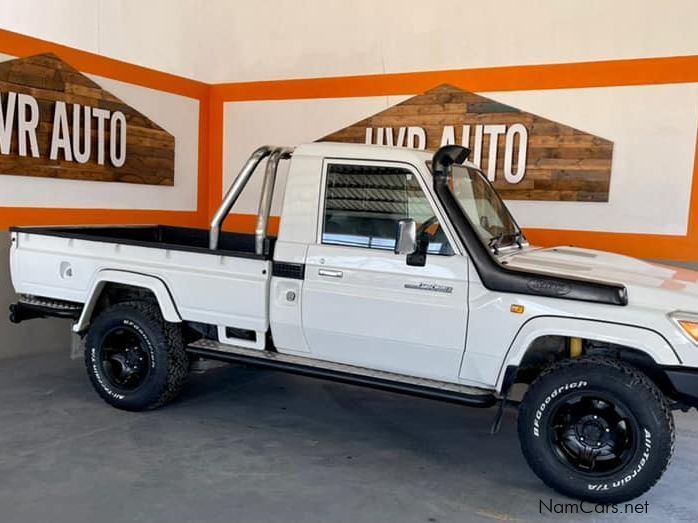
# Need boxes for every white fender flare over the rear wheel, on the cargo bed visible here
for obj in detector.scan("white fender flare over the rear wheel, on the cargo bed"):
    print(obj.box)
[73,269,182,332]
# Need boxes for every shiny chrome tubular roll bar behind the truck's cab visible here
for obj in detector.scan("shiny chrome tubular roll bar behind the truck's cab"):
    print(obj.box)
[208,145,293,255]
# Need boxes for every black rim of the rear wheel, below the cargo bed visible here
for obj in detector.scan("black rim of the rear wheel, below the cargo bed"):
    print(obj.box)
[99,325,150,392]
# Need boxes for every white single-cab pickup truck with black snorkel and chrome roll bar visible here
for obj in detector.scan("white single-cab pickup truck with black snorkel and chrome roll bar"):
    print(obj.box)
[5,143,698,503]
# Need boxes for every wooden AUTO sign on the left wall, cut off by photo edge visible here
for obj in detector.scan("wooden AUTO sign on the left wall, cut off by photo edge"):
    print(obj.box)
[0,54,175,185]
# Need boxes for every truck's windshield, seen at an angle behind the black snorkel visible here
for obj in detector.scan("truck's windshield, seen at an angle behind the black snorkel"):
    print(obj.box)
[448,165,525,251]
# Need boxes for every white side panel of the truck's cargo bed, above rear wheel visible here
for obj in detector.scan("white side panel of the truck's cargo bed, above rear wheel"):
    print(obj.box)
[11,232,270,332]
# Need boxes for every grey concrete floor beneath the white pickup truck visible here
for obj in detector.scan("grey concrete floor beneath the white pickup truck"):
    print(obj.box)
[0,354,698,523]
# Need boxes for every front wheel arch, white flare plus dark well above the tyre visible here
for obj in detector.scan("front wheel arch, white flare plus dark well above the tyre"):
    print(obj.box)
[497,316,681,392]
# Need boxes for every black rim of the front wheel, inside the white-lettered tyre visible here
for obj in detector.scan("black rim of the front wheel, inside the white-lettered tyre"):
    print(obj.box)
[548,392,639,477]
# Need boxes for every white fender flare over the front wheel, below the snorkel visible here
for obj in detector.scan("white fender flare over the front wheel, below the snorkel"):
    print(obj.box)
[497,316,681,391]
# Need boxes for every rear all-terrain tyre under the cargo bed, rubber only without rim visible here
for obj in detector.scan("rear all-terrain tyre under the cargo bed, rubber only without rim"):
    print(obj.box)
[85,301,189,411]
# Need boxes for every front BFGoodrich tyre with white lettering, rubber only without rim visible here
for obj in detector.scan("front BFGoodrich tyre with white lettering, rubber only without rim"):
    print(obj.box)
[518,356,674,503]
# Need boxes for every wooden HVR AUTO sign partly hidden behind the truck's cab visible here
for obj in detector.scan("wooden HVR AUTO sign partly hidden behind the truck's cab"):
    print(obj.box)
[322,85,613,202]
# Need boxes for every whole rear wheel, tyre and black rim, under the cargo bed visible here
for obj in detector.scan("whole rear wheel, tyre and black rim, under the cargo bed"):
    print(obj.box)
[85,301,188,411]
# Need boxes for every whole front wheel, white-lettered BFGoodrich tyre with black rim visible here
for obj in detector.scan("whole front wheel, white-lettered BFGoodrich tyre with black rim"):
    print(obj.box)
[518,356,674,503]
